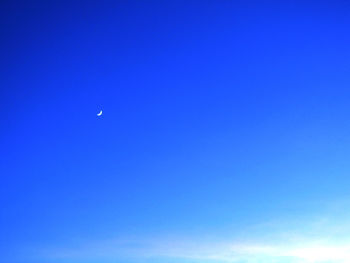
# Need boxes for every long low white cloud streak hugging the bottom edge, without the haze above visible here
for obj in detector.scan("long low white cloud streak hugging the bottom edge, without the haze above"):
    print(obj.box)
[41,237,350,263]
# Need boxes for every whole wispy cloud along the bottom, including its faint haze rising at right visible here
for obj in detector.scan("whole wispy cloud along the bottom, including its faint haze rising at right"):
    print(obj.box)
[39,210,350,263]
